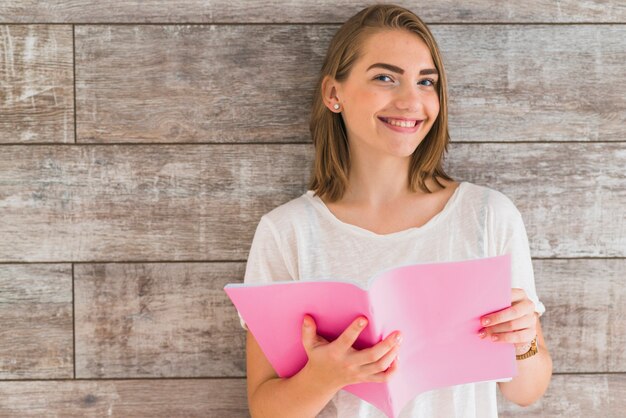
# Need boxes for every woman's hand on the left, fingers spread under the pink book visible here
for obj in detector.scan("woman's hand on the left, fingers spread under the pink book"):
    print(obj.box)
[302,315,400,390]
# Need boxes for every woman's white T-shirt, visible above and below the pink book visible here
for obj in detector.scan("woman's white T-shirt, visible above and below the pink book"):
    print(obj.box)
[239,182,545,418]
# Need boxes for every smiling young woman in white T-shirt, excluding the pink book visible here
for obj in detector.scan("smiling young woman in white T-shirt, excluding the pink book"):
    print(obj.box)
[241,5,552,418]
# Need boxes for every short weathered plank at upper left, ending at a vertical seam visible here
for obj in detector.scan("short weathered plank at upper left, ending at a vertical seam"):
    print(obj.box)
[0,25,74,144]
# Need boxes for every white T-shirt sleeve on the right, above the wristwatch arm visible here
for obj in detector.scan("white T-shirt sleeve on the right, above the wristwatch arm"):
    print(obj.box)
[489,192,546,316]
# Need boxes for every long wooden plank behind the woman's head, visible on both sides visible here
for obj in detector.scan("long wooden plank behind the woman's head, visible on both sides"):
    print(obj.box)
[76,25,626,143]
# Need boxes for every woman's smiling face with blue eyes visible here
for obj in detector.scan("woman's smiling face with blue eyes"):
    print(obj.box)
[329,30,439,157]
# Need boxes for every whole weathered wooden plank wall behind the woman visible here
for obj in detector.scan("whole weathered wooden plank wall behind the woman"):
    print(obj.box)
[0,0,626,417]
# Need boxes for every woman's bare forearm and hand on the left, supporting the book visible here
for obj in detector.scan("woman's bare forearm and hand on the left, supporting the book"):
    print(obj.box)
[247,315,400,418]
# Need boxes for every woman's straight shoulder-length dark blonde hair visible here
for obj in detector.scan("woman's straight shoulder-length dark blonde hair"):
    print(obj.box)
[308,4,453,201]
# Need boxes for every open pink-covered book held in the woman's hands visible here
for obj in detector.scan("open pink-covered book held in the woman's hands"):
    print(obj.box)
[224,254,517,418]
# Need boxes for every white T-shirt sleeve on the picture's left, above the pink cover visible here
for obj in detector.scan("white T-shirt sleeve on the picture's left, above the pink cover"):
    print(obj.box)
[237,215,292,330]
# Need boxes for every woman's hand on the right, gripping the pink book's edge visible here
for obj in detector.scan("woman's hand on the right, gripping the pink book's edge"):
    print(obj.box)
[478,288,537,348]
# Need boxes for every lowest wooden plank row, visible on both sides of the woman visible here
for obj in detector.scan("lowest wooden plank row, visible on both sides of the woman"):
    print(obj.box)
[0,374,626,418]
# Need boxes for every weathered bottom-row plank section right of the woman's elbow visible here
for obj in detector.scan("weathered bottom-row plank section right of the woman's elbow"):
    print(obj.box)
[498,374,626,418]
